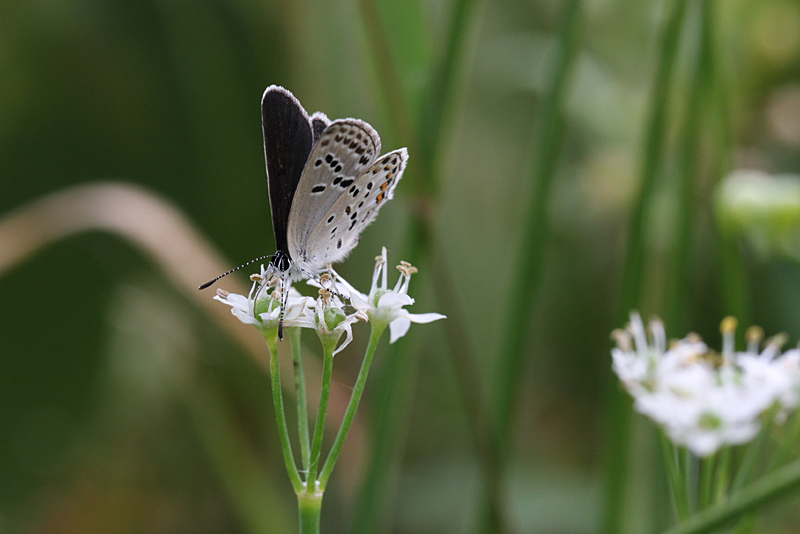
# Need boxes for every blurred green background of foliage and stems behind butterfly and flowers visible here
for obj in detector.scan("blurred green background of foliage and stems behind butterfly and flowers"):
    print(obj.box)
[0,0,800,534]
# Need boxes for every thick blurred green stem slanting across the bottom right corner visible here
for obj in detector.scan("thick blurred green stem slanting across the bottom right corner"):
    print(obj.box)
[665,460,800,534]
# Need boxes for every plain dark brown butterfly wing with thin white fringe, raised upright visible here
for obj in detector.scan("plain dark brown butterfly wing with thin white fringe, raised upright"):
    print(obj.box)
[261,85,313,253]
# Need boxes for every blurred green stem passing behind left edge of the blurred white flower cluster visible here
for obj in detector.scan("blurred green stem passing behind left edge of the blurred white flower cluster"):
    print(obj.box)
[601,0,686,534]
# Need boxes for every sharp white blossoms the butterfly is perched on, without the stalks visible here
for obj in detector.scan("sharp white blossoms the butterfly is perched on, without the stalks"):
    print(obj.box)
[214,247,445,354]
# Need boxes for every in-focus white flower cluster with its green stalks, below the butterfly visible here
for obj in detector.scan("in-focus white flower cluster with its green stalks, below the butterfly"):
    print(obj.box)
[214,252,445,534]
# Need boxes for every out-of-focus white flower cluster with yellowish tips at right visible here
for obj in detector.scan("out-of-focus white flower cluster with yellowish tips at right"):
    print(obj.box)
[611,312,800,456]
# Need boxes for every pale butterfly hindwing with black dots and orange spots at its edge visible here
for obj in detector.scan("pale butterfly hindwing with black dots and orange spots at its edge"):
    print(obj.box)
[290,148,408,272]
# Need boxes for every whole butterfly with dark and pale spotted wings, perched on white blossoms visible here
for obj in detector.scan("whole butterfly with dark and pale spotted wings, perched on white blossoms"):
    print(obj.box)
[200,85,408,324]
